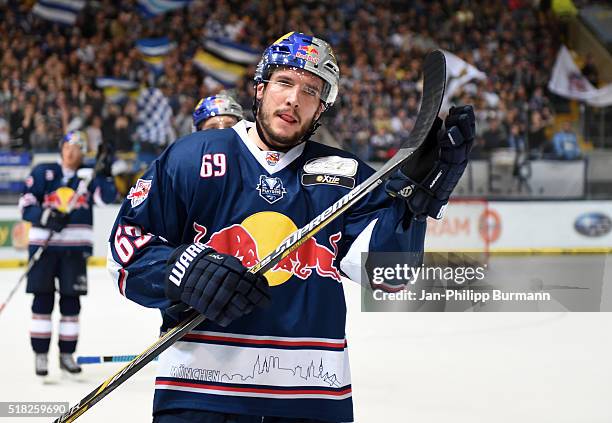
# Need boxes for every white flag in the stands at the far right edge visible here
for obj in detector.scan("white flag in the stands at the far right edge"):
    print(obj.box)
[548,46,612,107]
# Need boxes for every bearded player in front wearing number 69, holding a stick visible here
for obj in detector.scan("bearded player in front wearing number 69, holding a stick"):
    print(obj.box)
[108,33,474,423]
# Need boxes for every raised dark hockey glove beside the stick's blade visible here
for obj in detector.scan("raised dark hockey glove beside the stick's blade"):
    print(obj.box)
[386,106,476,220]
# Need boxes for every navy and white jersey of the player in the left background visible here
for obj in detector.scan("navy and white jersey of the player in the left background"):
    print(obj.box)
[19,163,117,254]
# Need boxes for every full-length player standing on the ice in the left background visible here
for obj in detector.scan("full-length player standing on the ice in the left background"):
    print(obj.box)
[19,131,117,376]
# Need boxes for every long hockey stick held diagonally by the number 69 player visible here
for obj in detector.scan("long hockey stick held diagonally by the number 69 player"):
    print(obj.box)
[55,50,446,423]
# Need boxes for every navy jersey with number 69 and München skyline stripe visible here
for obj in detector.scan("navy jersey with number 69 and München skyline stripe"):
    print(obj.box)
[108,121,425,422]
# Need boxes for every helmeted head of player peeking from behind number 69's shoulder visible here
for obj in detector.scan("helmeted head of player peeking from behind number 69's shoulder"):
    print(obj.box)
[193,94,244,131]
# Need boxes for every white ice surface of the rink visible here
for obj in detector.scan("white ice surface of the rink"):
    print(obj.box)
[0,268,612,423]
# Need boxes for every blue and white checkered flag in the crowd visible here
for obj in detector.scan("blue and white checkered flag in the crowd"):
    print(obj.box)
[136,88,176,146]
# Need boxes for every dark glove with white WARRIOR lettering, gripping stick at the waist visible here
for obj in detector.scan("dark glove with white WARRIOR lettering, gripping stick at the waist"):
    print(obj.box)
[166,243,270,326]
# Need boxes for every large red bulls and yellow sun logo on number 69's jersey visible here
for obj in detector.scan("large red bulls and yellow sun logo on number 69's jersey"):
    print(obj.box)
[193,212,342,286]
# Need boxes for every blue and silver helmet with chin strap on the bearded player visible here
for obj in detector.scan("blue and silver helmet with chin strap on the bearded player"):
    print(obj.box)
[253,32,340,142]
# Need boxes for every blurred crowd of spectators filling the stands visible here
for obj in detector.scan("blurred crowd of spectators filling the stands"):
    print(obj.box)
[0,0,580,166]
